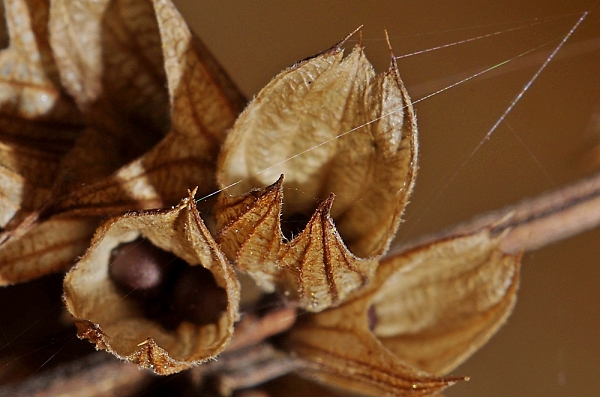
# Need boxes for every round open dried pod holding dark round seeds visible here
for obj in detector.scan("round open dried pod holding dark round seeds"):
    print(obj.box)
[64,190,239,374]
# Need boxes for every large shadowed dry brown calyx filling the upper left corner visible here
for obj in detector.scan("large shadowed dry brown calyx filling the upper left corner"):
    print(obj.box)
[0,0,244,283]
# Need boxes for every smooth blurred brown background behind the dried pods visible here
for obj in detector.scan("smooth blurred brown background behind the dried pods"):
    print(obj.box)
[176,0,600,397]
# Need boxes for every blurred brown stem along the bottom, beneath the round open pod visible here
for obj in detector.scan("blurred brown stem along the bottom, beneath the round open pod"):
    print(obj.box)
[0,307,297,397]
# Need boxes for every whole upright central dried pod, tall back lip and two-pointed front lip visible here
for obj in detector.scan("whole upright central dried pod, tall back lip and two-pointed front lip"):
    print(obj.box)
[215,36,417,311]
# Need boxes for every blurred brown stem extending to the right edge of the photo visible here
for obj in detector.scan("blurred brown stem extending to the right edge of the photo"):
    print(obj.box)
[388,173,600,256]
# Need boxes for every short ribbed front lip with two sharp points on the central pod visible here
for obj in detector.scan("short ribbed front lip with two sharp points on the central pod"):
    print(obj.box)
[217,177,377,312]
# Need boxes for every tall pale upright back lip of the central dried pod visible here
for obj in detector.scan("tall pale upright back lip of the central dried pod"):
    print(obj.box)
[217,37,417,257]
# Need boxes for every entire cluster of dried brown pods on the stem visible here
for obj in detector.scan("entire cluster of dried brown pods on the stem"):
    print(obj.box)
[5,0,596,396]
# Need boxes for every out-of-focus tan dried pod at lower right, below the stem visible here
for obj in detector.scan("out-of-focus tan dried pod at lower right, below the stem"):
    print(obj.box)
[289,230,519,395]
